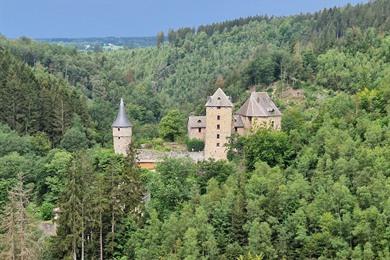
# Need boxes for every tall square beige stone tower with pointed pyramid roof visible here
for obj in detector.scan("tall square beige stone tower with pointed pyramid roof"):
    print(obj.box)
[204,88,233,160]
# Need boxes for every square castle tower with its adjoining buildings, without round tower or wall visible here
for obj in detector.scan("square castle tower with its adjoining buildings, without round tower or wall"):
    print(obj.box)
[187,88,282,160]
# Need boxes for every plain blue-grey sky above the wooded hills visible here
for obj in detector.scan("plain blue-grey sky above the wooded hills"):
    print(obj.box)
[0,0,367,38]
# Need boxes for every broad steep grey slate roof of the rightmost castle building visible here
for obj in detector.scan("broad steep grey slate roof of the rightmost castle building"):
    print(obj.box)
[237,92,282,117]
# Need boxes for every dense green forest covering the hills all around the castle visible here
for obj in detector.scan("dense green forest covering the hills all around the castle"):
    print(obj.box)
[0,0,390,260]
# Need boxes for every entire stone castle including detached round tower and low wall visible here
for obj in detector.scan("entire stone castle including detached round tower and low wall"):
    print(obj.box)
[112,88,282,164]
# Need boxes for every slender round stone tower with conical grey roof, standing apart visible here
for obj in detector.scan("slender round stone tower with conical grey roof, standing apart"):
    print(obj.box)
[112,98,132,155]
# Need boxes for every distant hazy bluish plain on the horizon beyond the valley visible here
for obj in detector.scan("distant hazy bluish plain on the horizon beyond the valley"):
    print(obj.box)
[37,37,156,51]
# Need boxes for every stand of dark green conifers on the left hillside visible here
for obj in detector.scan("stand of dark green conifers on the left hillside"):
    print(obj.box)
[0,49,88,142]
